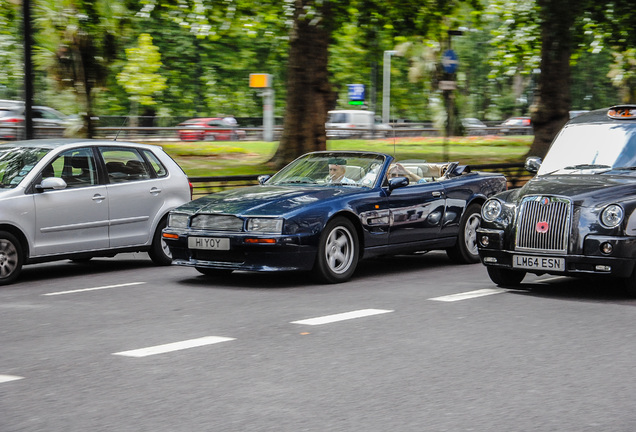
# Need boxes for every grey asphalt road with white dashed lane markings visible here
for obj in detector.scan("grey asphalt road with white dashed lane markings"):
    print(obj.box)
[0,253,636,432]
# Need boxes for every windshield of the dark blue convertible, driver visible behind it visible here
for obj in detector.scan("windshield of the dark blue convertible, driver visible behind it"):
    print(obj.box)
[267,152,384,188]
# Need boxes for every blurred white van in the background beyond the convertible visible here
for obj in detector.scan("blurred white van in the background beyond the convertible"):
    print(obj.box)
[325,110,391,138]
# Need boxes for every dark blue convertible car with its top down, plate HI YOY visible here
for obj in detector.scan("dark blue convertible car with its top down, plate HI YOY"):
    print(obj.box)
[163,152,506,283]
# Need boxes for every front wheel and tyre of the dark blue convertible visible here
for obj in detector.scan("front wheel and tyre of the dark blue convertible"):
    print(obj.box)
[313,217,360,283]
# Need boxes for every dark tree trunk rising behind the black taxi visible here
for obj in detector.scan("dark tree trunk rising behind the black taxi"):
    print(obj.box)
[528,0,578,157]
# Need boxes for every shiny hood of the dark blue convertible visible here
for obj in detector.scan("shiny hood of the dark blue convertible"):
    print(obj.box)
[178,185,360,216]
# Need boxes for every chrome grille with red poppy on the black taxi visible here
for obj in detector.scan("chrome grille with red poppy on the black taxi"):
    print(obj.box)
[516,195,572,253]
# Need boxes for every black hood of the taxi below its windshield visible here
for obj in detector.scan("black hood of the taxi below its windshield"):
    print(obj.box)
[517,175,636,207]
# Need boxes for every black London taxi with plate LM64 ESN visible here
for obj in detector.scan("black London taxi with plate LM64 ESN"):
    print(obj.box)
[477,105,636,295]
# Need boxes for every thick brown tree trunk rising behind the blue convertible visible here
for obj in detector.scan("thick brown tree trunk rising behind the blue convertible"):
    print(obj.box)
[270,0,336,169]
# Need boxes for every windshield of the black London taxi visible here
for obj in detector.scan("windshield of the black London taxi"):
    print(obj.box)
[538,123,636,175]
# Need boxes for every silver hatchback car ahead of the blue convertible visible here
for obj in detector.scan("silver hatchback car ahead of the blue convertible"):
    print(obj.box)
[0,139,192,285]
